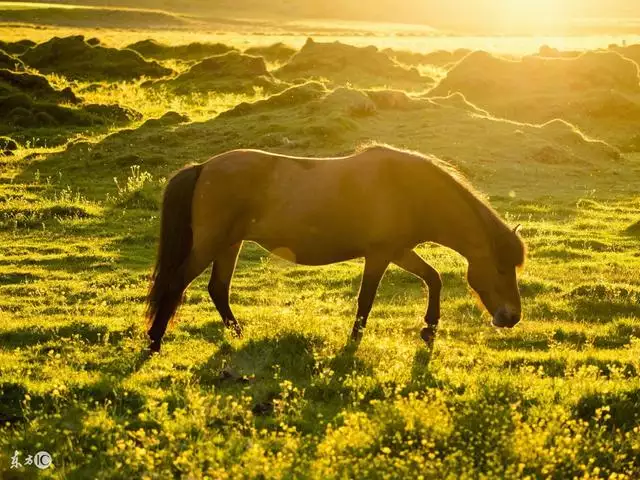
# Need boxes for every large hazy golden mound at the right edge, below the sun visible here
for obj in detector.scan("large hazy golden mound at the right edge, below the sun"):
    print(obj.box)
[430,52,640,148]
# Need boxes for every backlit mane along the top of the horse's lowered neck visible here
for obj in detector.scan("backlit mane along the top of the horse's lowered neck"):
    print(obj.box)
[364,145,526,266]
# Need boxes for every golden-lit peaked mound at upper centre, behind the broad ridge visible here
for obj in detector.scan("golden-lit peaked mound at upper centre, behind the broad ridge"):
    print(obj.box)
[274,39,433,90]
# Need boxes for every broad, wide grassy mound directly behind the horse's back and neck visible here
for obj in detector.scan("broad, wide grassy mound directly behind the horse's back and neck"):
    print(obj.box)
[46,82,622,195]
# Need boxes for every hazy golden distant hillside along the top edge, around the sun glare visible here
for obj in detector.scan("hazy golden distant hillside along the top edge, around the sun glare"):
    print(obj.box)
[5,0,640,33]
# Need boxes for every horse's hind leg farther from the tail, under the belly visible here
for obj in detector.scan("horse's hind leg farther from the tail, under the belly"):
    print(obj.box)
[208,242,242,337]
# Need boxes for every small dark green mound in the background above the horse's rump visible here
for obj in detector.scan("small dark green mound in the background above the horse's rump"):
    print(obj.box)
[151,51,278,95]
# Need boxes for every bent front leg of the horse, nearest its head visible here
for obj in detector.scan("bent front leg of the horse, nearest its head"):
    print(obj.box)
[393,250,442,344]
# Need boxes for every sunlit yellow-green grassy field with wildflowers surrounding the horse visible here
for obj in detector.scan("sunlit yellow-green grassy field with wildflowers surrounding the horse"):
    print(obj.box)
[0,14,640,479]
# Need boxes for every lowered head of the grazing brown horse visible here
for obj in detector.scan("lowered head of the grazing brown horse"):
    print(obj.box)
[467,227,525,328]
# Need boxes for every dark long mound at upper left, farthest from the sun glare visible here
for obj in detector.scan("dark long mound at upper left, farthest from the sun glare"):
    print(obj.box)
[21,35,173,81]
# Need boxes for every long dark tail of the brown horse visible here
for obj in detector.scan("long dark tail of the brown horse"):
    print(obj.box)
[146,165,202,341]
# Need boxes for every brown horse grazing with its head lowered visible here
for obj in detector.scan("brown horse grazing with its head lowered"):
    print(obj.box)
[147,146,525,351]
